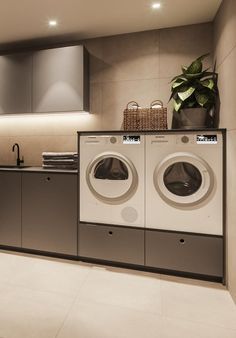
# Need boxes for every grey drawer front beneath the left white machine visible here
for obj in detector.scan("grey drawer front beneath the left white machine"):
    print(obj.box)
[78,224,144,265]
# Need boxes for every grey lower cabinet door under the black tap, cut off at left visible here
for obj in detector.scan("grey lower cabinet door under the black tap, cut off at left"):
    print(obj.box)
[0,171,21,247]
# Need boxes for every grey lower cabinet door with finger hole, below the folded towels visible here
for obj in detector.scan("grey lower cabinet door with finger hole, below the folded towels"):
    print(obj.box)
[22,173,77,255]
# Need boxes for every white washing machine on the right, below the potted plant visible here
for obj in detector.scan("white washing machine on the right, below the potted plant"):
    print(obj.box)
[146,131,223,235]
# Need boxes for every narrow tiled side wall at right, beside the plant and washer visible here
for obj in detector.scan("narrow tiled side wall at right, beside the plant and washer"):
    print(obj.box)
[214,0,236,301]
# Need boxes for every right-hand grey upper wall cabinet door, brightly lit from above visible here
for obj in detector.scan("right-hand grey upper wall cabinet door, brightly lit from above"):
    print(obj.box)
[33,46,88,112]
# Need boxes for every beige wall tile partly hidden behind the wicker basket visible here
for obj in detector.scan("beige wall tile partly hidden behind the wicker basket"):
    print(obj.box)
[102,79,159,130]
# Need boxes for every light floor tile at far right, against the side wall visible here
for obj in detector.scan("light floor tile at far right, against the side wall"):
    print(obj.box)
[161,277,236,330]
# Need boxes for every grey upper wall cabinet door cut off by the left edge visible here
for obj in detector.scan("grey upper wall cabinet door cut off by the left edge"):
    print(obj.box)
[0,53,32,114]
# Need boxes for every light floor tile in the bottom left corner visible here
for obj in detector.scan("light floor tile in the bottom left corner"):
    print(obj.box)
[0,284,74,338]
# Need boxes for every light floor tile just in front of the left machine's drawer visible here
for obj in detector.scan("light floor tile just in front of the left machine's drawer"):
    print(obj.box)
[78,269,161,314]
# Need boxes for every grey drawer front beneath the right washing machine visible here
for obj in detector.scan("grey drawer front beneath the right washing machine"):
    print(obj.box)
[145,230,223,277]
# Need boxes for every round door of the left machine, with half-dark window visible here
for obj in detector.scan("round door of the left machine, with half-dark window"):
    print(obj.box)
[86,152,138,204]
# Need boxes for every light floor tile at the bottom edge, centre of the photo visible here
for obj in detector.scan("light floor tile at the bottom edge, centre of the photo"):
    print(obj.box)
[57,302,161,338]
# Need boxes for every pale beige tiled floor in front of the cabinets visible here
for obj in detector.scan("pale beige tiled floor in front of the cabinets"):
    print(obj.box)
[0,251,236,338]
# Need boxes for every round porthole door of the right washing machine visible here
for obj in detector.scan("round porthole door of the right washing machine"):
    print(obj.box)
[153,152,214,207]
